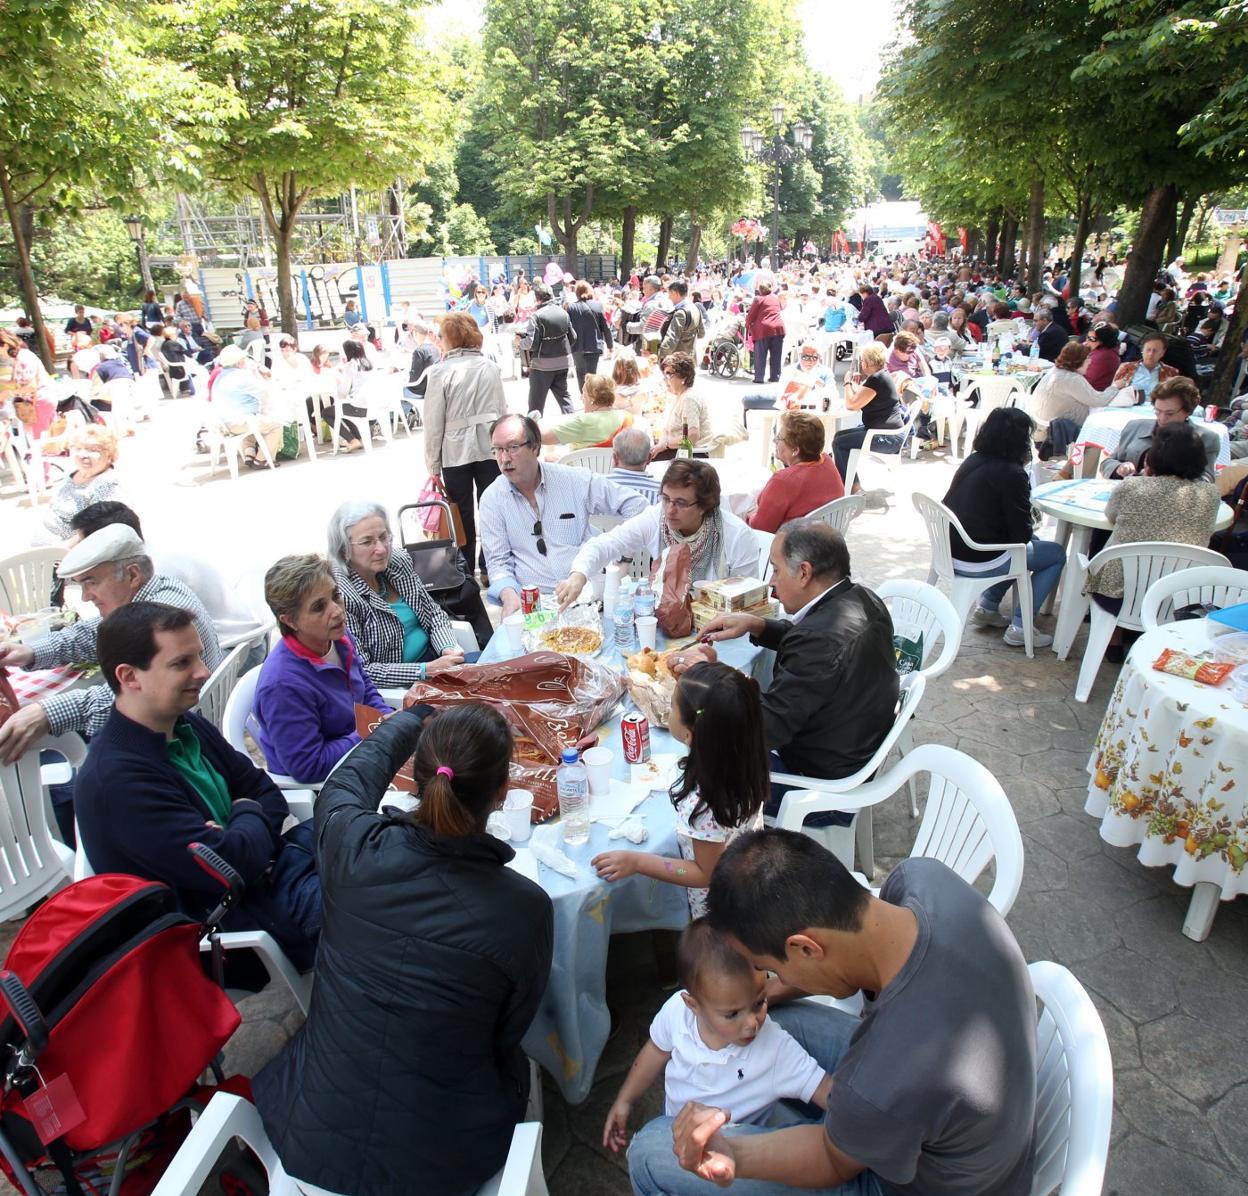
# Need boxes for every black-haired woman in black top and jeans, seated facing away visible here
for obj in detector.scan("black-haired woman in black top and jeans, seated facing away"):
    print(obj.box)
[945,407,1066,648]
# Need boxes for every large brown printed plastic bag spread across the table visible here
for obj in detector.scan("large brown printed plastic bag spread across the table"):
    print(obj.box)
[356,652,624,823]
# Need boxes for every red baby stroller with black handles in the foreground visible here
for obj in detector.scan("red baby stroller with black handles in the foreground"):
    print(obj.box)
[0,844,251,1196]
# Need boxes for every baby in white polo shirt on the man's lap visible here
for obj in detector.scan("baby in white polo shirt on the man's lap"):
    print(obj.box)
[603,918,832,1151]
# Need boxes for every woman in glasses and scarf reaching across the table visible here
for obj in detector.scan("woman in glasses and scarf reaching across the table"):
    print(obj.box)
[554,459,759,609]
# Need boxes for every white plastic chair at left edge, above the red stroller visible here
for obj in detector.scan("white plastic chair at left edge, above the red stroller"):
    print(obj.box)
[0,735,82,921]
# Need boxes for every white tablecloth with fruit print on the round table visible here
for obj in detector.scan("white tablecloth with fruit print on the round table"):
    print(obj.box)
[1085,619,1248,900]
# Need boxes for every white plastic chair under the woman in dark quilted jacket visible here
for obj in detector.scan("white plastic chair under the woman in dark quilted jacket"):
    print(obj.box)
[152,1092,548,1196]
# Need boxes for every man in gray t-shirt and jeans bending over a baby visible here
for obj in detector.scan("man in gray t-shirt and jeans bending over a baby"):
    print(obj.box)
[629,830,1036,1196]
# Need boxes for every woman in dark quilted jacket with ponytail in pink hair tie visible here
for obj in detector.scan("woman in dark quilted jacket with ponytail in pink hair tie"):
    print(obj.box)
[253,703,554,1196]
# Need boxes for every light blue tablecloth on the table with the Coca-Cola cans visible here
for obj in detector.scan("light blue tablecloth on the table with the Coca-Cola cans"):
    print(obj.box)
[480,628,774,1104]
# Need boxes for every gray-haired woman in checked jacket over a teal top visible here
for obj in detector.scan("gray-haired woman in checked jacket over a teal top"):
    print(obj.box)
[329,502,475,685]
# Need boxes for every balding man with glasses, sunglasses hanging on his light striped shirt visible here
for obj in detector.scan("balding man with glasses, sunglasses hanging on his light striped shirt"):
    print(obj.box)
[478,416,648,618]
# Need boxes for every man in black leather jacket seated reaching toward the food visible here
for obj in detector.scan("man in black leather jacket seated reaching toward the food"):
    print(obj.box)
[703,519,899,813]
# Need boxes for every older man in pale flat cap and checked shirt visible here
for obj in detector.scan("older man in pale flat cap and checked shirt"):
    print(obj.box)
[0,523,221,764]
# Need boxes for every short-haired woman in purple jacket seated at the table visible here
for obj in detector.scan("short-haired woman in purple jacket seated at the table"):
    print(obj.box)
[255,553,391,784]
